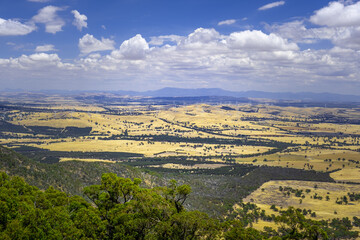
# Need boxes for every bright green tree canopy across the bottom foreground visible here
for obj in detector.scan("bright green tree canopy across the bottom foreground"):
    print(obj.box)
[0,173,357,240]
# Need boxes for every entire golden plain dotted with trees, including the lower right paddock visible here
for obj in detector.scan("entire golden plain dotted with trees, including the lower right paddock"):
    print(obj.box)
[0,96,360,223]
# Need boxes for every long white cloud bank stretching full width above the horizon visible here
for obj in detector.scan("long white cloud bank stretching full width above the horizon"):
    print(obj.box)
[0,26,360,92]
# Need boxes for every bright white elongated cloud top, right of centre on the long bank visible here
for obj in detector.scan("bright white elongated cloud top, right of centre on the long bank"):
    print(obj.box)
[226,30,299,51]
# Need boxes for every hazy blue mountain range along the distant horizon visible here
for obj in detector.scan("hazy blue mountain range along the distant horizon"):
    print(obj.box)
[112,88,360,102]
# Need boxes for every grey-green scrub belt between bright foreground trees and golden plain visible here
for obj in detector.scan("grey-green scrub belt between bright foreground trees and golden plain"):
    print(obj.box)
[0,146,333,216]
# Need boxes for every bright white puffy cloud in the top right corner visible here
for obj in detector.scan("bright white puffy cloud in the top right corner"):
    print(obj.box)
[310,2,360,27]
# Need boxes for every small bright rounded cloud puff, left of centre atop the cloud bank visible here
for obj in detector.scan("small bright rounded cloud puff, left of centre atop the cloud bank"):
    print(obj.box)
[112,34,149,60]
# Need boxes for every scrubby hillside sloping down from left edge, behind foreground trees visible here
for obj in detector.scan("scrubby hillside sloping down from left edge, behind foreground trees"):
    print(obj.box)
[0,146,160,194]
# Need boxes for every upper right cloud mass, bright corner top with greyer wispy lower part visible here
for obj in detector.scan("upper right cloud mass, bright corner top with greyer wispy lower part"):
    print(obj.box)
[266,1,360,50]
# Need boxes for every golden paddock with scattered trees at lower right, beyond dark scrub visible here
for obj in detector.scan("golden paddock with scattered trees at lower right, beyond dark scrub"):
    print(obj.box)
[243,181,360,219]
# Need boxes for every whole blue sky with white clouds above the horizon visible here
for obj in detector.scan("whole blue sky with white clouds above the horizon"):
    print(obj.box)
[0,0,360,95]
